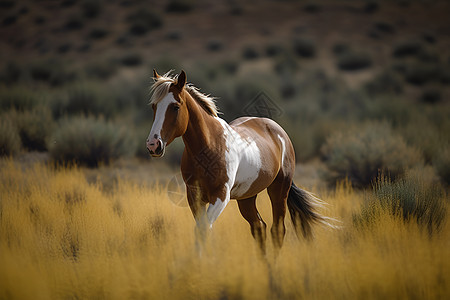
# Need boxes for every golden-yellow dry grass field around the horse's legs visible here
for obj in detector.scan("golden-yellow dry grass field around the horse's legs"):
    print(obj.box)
[0,161,450,299]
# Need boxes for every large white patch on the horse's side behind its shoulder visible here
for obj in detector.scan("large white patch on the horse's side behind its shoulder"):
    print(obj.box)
[217,118,262,199]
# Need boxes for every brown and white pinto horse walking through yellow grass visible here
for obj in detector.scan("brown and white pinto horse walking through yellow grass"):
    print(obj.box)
[146,70,333,252]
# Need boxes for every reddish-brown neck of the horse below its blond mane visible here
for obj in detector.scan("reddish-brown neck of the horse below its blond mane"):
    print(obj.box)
[183,93,221,155]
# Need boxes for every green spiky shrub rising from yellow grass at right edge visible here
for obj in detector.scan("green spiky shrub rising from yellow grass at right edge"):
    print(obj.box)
[353,172,446,235]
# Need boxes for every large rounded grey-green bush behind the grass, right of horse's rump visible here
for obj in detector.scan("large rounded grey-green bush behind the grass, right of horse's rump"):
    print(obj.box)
[322,123,422,187]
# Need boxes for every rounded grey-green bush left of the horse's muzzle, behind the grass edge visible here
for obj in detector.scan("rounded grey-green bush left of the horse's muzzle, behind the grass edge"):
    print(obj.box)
[49,117,136,167]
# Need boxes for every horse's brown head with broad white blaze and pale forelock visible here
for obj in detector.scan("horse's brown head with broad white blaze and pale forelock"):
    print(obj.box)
[147,70,189,157]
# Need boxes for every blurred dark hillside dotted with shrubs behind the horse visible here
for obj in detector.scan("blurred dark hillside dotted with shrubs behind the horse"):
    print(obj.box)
[0,0,450,189]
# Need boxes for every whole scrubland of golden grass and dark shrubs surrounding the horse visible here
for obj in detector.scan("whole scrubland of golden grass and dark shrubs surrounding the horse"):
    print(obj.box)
[0,0,450,299]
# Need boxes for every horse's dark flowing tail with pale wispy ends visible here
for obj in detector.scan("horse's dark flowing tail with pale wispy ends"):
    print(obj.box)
[287,182,339,239]
